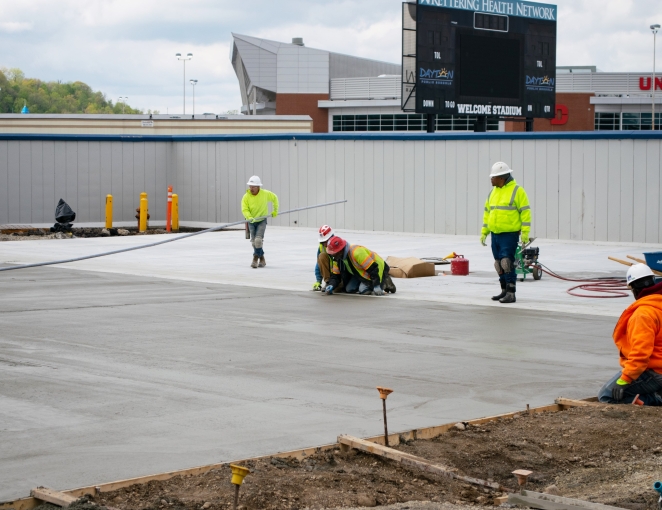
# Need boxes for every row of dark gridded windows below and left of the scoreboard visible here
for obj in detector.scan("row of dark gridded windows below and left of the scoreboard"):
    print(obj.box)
[332,113,499,132]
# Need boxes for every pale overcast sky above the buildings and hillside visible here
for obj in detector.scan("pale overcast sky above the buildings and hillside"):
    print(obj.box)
[0,0,662,113]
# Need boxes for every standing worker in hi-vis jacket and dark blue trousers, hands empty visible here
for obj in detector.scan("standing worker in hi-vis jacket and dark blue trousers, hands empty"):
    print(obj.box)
[480,162,531,303]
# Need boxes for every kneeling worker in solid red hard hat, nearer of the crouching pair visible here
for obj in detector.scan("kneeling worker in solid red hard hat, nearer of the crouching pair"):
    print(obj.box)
[324,236,395,296]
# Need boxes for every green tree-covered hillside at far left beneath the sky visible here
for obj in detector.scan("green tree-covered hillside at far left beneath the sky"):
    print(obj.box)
[0,67,143,113]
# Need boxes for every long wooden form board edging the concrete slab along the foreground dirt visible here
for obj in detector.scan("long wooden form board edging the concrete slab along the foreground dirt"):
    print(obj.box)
[0,398,597,510]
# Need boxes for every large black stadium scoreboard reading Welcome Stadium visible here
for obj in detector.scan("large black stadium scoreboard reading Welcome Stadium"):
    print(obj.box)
[402,0,557,118]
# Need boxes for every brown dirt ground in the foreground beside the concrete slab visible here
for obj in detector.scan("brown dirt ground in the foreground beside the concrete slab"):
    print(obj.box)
[78,406,662,510]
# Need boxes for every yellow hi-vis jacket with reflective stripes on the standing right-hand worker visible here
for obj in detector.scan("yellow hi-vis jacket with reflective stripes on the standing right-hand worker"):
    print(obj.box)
[481,179,531,236]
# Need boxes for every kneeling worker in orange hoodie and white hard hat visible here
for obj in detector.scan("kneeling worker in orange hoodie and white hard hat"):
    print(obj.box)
[598,264,662,406]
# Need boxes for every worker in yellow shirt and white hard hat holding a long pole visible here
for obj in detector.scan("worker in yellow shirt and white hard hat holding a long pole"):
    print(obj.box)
[241,175,278,268]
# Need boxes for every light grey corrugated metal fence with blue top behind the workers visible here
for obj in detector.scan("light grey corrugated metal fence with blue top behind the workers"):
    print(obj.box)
[0,133,662,243]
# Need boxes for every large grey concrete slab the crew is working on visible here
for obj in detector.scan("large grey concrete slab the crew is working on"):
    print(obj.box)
[0,227,659,500]
